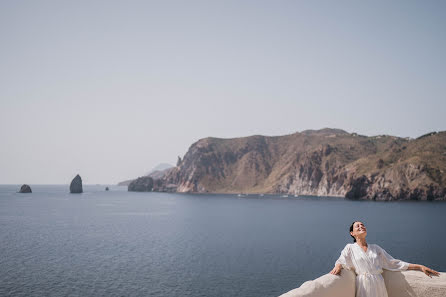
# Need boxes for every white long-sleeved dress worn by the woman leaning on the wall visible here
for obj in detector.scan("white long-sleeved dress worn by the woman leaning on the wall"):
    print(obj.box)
[336,243,409,297]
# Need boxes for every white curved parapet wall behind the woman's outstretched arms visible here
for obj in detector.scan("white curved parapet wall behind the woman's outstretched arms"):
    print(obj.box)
[279,270,446,297]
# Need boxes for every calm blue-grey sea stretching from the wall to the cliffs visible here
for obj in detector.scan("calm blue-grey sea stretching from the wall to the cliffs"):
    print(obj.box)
[0,185,446,297]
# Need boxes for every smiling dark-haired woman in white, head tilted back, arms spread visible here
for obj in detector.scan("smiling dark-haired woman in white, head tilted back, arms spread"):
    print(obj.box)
[330,221,439,297]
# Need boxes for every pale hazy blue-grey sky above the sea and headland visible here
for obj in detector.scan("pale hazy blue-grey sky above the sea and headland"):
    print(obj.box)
[0,0,446,184]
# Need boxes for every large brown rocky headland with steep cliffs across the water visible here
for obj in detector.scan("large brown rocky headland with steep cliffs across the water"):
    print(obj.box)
[153,129,446,200]
